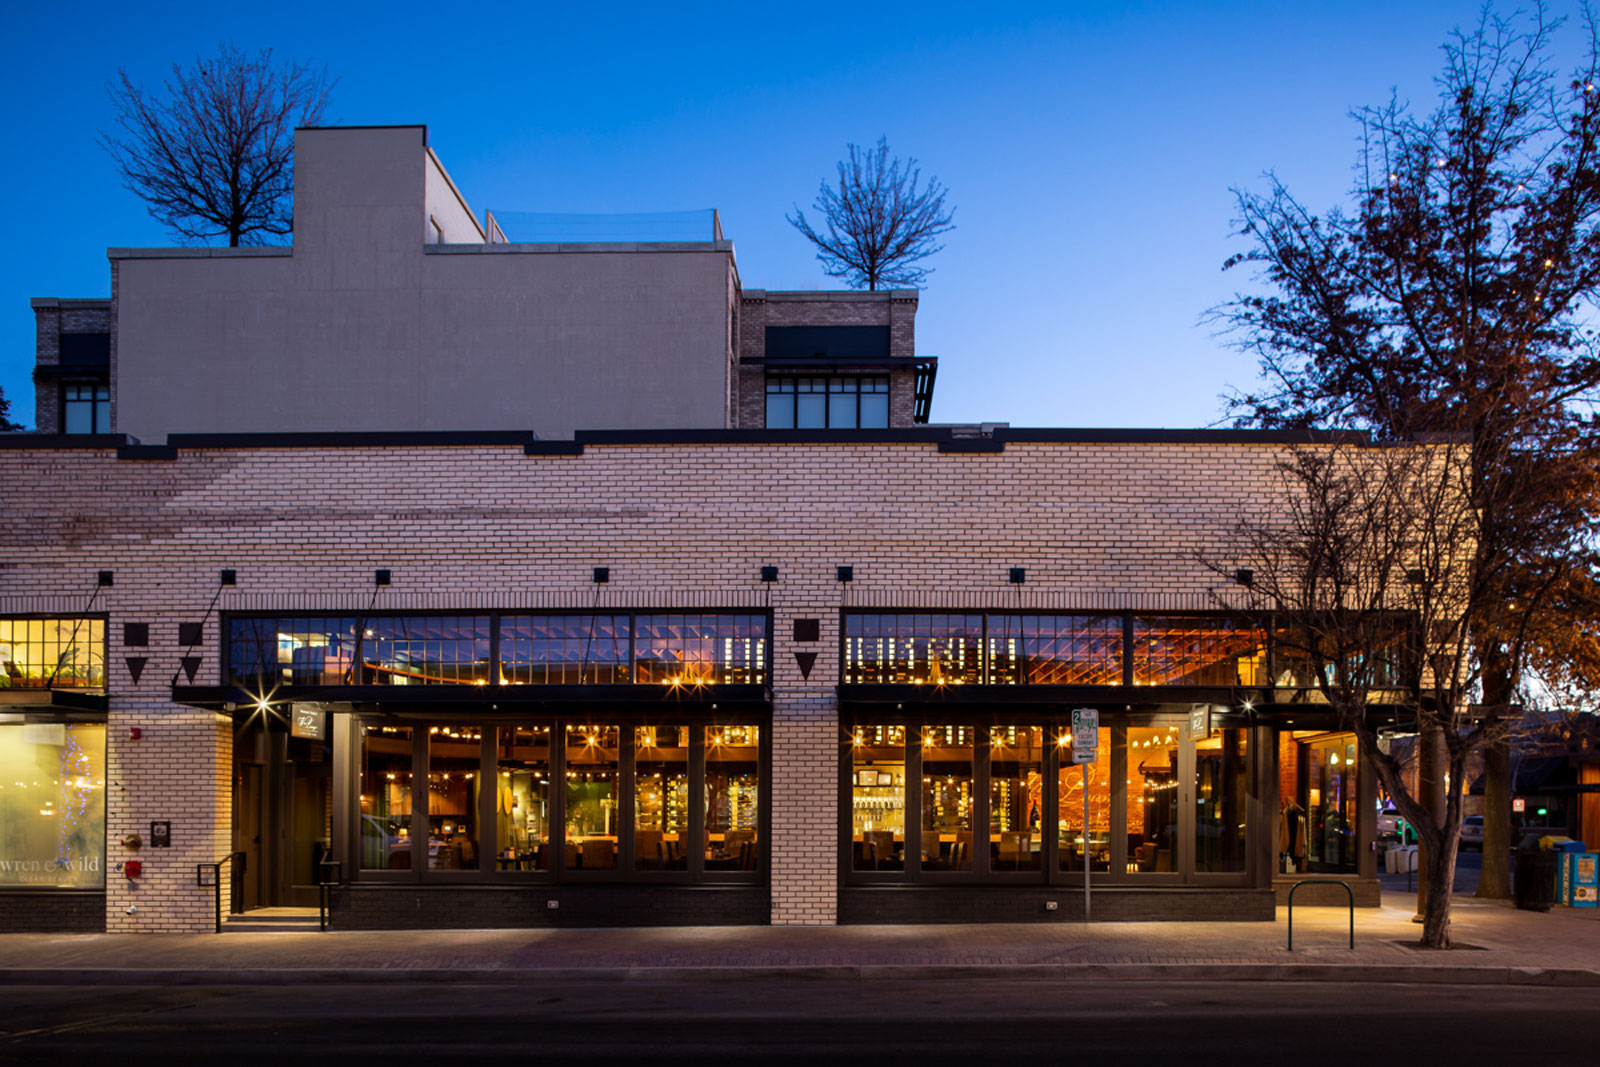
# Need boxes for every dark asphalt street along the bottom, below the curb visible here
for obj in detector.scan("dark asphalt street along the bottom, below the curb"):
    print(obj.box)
[0,979,1600,1067]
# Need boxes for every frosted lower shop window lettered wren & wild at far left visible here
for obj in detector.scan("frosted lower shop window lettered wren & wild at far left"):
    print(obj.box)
[0,723,106,889]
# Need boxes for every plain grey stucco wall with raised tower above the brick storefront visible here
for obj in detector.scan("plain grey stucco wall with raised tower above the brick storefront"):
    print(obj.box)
[110,126,733,442]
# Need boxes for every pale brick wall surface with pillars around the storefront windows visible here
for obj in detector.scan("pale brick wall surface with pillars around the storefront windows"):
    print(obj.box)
[0,443,1376,931]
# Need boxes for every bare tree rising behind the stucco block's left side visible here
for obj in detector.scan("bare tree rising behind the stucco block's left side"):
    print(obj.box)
[99,45,333,245]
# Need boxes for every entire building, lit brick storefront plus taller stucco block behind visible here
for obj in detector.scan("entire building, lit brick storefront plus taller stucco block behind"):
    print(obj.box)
[0,130,1401,931]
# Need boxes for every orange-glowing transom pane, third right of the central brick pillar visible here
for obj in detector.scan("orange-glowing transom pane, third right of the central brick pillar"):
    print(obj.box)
[1133,616,1270,686]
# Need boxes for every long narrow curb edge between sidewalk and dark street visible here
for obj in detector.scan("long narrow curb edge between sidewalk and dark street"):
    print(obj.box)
[0,963,1600,989]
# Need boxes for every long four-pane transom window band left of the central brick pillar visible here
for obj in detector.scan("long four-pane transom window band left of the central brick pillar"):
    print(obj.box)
[227,613,768,686]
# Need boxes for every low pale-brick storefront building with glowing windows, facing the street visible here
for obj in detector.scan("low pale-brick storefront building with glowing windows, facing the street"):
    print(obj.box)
[0,429,1395,933]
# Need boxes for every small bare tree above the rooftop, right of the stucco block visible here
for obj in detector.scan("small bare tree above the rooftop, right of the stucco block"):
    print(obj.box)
[784,138,955,290]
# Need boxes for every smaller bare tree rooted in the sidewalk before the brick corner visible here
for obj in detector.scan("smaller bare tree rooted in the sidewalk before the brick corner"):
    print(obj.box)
[1211,442,1526,949]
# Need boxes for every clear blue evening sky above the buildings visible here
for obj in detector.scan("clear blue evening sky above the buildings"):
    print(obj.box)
[0,0,1529,427]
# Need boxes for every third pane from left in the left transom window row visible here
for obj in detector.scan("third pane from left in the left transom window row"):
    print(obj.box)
[501,614,632,685]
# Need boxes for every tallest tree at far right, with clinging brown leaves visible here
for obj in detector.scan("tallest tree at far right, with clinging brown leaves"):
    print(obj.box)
[1216,5,1600,896]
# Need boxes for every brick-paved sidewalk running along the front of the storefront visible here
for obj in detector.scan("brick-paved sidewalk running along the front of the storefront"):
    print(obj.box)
[0,893,1600,987]
